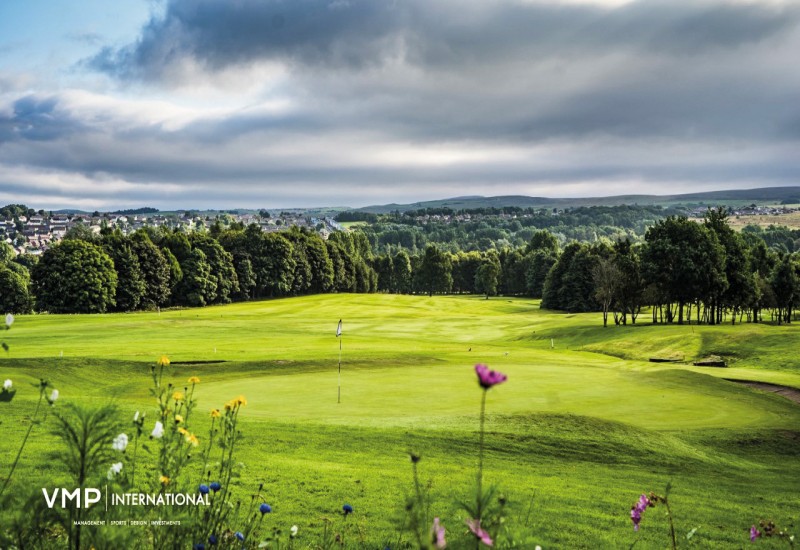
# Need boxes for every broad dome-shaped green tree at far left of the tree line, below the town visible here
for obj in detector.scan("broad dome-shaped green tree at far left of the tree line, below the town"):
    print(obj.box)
[31,240,117,313]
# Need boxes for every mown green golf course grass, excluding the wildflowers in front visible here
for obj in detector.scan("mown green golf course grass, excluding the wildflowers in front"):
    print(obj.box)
[0,300,800,549]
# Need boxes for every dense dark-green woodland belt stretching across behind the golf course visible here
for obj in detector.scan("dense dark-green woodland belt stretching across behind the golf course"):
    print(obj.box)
[0,207,800,324]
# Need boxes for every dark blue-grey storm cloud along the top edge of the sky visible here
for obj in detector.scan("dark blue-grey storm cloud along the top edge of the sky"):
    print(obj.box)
[93,0,798,79]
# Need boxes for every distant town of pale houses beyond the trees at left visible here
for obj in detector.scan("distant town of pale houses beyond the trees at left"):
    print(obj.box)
[0,209,344,255]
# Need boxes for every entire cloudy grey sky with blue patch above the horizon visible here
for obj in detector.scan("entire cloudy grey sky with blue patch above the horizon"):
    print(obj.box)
[0,0,800,210]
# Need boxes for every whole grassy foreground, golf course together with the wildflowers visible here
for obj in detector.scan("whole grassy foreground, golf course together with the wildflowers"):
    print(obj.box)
[0,295,800,550]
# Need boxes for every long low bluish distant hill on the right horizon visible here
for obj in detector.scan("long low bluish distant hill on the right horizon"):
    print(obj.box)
[358,187,800,214]
